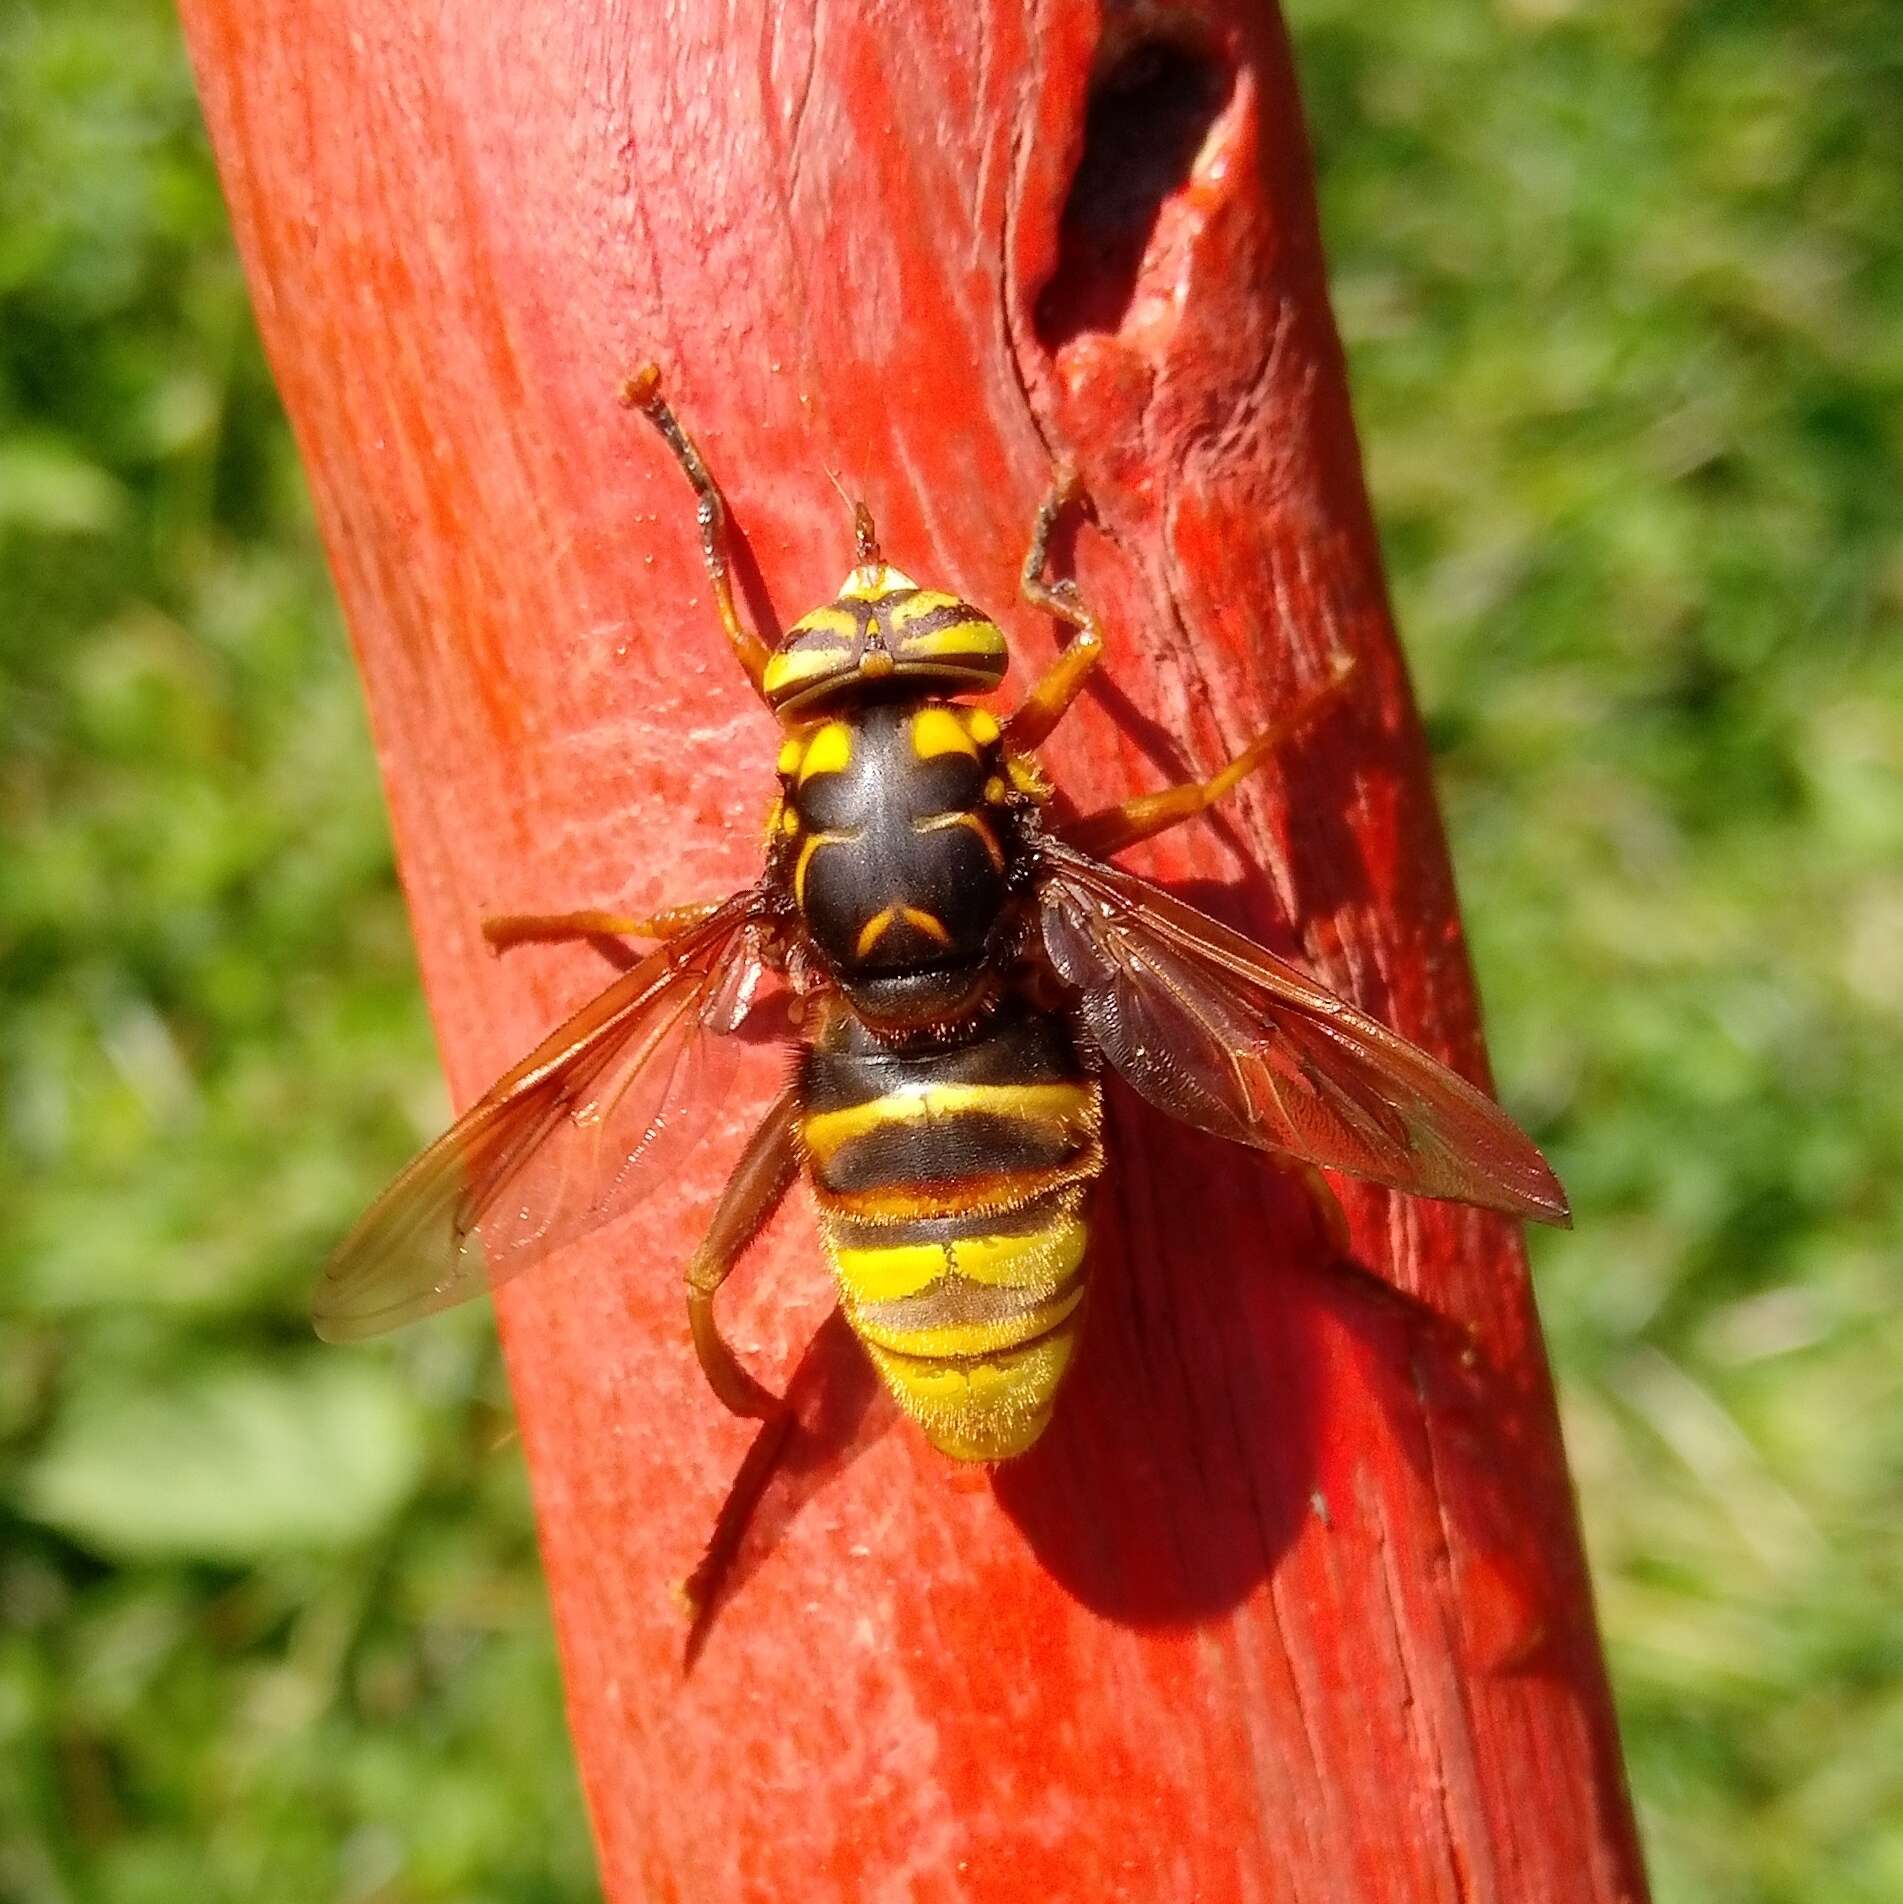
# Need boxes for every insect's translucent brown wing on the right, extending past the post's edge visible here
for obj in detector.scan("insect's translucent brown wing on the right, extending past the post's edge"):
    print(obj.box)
[1040,843,1572,1224]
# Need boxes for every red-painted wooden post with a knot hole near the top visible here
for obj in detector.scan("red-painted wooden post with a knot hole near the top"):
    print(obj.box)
[185,0,1644,1904]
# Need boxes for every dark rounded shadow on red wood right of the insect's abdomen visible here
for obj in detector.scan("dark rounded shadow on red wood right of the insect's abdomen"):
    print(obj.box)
[992,1081,1330,1626]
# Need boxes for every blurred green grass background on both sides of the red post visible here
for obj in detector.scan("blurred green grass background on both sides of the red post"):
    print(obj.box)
[0,0,1903,1904]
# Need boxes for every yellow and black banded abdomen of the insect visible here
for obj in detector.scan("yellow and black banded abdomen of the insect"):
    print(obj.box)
[802,1000,1103,1460]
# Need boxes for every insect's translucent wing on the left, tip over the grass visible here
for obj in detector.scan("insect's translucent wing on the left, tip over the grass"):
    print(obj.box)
[312,891,768,1342]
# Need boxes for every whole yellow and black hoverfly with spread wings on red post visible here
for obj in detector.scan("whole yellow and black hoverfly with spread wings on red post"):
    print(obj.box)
[316,366,1568,1460]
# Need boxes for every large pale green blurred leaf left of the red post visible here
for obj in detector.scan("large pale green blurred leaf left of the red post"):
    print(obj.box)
[21,1352,423,1565]
